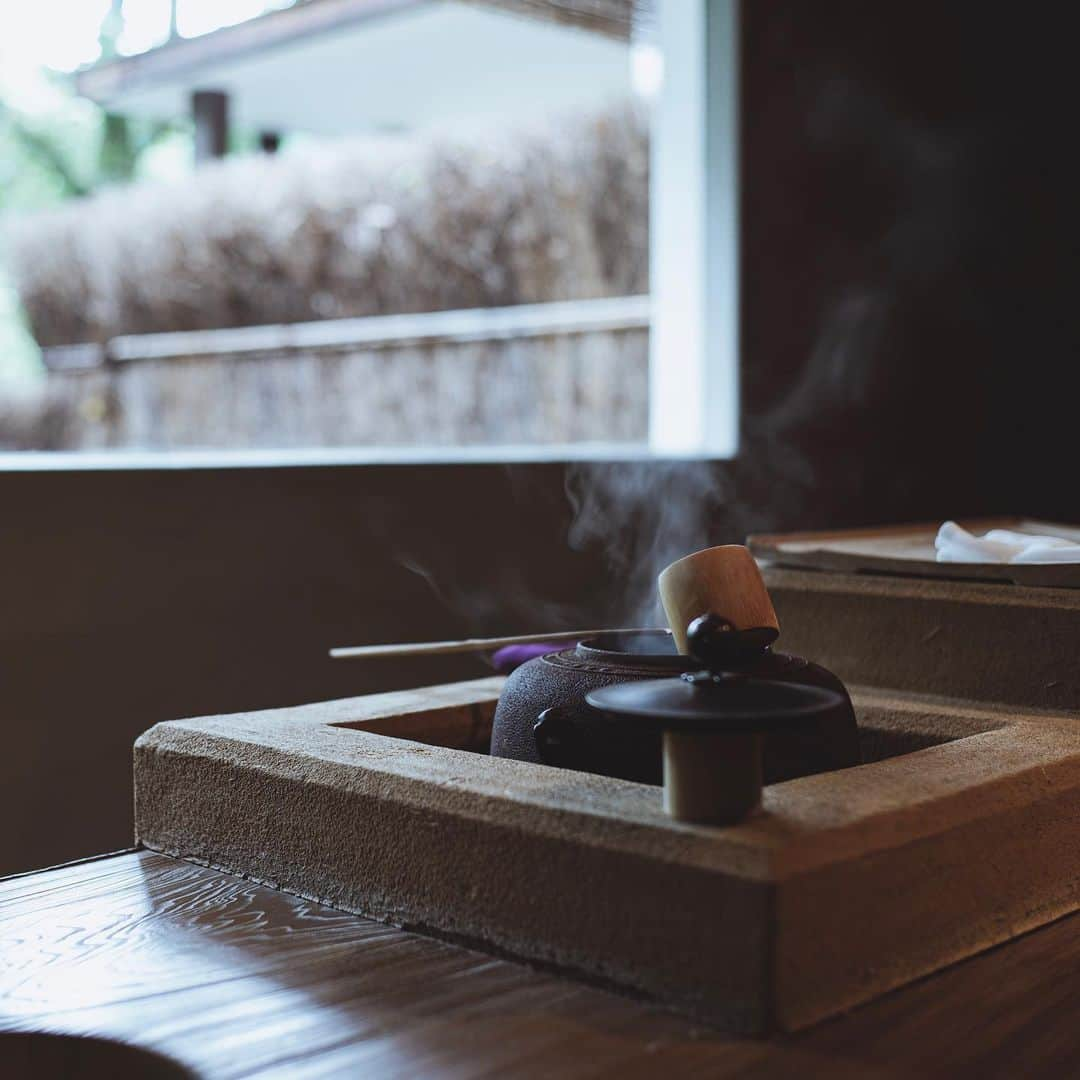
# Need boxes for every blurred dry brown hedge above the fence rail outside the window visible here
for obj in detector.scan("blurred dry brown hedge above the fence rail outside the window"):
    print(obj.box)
[8,108,648,346]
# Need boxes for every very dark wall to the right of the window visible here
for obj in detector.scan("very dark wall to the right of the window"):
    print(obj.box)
[743,0,1080,522]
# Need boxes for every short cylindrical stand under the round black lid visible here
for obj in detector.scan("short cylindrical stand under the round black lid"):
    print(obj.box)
[663,730,761,825]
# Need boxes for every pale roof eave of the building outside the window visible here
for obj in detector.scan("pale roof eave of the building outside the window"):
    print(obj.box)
[76,0,634,135]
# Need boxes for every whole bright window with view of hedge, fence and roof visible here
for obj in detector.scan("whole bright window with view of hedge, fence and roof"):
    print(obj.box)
[0,0,738,457]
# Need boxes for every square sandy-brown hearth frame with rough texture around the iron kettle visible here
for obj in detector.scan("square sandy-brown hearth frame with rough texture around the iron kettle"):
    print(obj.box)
[135,678,1080,1032]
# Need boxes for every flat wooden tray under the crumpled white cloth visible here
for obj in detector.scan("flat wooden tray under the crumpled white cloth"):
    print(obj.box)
[747,517,1080,589]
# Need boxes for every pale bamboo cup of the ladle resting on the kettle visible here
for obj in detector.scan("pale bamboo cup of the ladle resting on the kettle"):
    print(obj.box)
[657,544,780,652]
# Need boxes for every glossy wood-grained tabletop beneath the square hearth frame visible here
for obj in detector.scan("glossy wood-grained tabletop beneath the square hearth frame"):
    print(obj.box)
[0,851,1080,1078]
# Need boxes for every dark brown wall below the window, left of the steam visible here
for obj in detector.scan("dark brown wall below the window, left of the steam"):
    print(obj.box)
[0,465,622,874]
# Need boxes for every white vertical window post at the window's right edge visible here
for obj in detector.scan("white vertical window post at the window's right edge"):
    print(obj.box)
[649,0,739,458]
